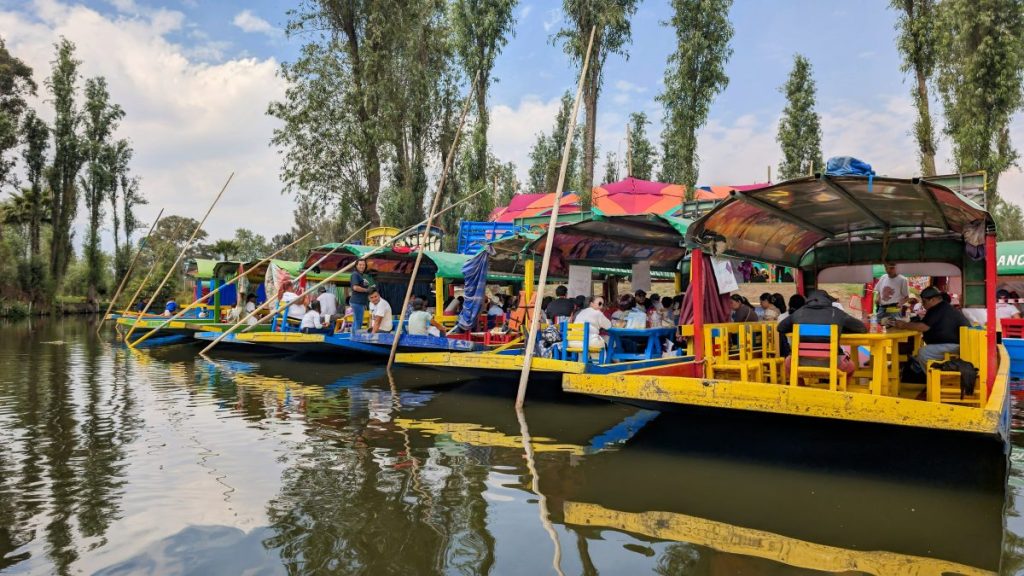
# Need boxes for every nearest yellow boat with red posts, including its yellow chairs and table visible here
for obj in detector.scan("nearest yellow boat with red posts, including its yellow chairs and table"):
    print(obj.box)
[562,175,1010,443]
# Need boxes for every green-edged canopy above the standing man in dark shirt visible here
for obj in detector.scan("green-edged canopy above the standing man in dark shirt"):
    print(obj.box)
[305,243,522,284]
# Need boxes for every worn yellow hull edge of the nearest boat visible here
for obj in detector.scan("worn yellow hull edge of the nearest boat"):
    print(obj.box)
[562,346,1010,435]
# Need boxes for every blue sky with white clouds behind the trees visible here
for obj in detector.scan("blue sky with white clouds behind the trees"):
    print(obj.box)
[0,0,1024,248]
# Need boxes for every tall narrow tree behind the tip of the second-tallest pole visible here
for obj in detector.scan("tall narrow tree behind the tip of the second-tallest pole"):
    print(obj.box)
[451,0,517,190]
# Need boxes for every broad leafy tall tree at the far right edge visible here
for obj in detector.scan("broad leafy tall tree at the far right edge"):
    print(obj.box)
[936,0,1024,208]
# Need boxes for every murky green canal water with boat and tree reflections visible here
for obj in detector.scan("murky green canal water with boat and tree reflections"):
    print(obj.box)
[0,320,1024,575]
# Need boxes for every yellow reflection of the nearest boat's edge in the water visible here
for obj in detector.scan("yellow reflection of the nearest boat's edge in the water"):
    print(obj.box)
[562,502,995,576]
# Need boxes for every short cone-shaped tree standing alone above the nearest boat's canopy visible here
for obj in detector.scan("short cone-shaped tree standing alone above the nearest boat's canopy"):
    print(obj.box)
[775,54,824,179]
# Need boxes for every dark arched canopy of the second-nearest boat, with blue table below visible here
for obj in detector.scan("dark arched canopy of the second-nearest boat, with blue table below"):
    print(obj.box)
[489,214,690,276]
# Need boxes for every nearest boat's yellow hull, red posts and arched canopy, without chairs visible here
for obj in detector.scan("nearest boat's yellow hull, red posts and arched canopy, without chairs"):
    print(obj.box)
[562,175,1010,443]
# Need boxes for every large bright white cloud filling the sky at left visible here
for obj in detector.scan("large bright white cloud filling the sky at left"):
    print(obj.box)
[0,0,293,243]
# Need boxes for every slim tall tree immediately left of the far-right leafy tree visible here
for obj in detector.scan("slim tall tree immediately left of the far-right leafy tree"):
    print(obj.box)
[891,0,940,176]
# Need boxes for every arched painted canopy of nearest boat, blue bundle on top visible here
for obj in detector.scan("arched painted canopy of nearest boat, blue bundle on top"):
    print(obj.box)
[686,174,994,269]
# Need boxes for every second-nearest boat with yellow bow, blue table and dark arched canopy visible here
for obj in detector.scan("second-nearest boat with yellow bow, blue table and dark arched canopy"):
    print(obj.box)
[396,214,691,381]
